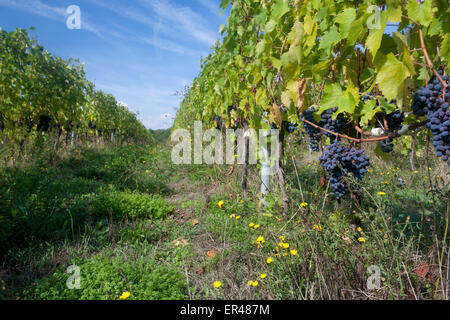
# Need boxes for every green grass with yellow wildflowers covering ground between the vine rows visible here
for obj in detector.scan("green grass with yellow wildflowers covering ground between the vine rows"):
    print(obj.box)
[0,136,448,299]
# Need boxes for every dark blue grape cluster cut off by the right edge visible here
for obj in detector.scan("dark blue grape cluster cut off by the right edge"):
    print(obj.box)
[412,71,450,166]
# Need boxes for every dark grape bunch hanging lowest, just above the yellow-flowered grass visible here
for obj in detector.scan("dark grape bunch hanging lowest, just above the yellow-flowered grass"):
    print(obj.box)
[320,141,370,200]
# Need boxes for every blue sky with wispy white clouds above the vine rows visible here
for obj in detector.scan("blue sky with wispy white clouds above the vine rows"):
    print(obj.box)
[0,0,228,129]
